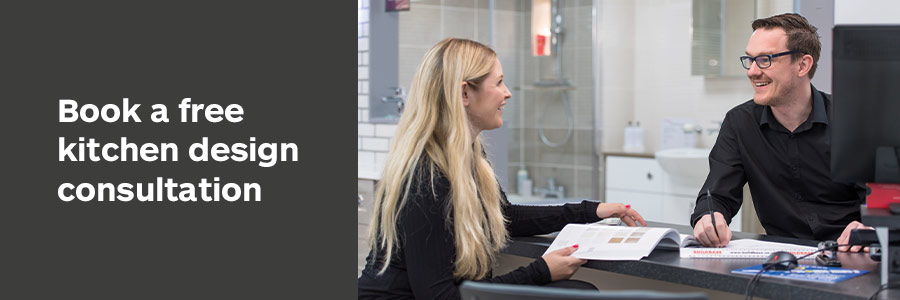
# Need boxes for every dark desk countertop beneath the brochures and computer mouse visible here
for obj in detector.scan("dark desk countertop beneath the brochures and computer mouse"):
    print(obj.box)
[503,222,896,300]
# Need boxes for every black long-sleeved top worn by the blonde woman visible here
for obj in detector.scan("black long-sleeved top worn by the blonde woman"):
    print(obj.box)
[357,159,600,299]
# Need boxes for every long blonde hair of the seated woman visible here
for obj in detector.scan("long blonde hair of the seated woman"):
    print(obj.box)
[369,38,508,279]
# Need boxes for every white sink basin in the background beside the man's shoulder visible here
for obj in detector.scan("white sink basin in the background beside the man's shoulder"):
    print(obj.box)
[656,148,711,186]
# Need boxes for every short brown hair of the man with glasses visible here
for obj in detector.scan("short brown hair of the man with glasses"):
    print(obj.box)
[752,13,822,79]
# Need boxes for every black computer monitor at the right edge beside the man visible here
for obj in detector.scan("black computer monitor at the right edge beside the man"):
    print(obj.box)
[831,25,900,183]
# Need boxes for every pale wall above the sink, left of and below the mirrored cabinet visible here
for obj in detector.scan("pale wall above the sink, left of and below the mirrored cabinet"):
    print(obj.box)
[598,0,753,152]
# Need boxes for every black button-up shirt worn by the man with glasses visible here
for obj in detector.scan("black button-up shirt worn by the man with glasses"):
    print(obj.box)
[691,85,862,240]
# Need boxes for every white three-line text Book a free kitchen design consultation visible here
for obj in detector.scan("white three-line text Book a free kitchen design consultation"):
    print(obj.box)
[57,98,299,202]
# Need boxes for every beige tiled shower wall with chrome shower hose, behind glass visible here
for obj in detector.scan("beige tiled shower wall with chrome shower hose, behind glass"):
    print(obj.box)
[504,1,597,202]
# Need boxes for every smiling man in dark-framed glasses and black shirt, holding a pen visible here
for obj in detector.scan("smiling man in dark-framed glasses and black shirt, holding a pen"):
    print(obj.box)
[691,13,865,252]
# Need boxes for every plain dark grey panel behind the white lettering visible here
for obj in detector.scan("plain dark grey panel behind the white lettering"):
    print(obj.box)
[0,1,356,299]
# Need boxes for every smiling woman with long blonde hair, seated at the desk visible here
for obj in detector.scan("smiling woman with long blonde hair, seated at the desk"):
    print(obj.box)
[358,38,646,299]
